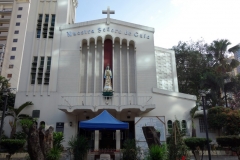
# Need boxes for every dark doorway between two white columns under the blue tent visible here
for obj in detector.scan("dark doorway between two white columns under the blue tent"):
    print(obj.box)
[99,130,116,150]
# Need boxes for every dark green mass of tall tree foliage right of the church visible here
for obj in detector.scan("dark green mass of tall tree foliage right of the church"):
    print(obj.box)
[173,39,240,107]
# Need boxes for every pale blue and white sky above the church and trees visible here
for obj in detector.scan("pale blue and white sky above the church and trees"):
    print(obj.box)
[75,0,240,48]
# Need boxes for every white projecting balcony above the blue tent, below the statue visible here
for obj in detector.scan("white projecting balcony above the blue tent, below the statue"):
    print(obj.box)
[58,96,155,115]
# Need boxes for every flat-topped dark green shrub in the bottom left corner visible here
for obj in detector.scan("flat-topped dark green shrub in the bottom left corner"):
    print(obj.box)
[1,139,26,158]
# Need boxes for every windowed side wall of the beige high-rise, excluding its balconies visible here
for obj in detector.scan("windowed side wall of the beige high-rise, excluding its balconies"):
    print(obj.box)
[0,0,31,89]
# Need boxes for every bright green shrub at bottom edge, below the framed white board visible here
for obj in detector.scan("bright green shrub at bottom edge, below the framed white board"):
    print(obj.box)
[148,144,167,160]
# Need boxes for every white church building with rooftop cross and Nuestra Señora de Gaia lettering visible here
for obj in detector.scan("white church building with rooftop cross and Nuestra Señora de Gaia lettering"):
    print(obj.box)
[2,0,200,158]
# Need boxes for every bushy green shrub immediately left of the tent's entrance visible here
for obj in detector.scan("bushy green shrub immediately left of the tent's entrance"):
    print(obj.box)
[68,135,89,160]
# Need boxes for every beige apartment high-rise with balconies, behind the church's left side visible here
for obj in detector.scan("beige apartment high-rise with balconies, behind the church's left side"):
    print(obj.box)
[0,0,31,89]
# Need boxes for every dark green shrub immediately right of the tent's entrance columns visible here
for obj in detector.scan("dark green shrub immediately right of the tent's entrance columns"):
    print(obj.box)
[122,139,140,160]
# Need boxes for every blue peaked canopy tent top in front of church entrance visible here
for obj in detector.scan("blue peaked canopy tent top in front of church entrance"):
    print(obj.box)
[79,110,129,130]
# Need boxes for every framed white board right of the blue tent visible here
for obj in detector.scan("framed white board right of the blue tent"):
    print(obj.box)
[135,116,166,149]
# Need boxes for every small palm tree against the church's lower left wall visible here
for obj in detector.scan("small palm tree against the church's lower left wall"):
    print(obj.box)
[6,102,33,138]
